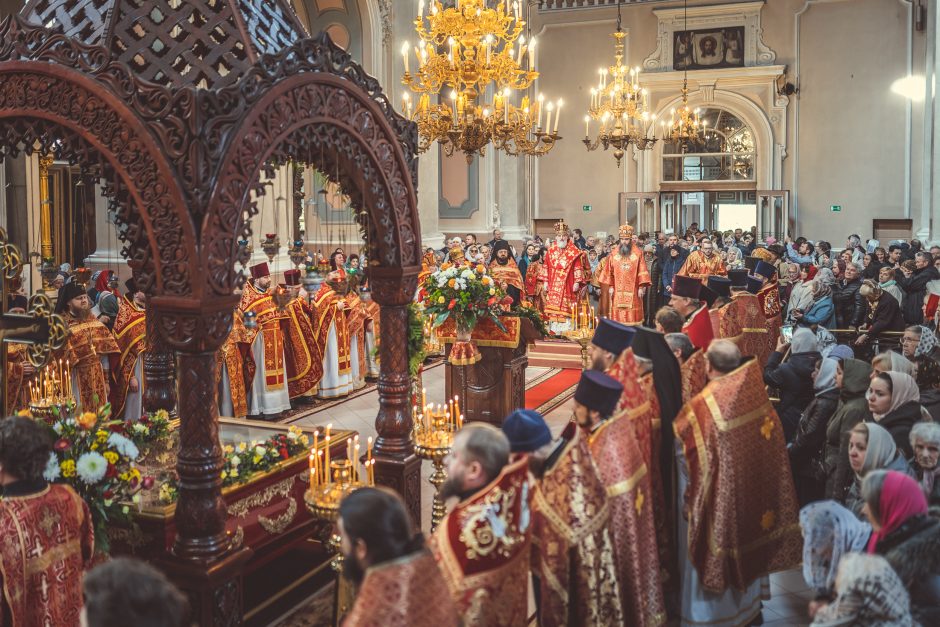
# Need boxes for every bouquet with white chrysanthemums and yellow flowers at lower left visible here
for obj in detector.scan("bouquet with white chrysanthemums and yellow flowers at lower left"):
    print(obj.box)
[21,403,170,553]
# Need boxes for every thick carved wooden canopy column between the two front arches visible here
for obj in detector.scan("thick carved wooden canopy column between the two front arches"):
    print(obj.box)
[150,297,251,625]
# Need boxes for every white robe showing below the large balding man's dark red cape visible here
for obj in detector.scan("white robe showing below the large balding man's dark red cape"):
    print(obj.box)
[676,441,766,627]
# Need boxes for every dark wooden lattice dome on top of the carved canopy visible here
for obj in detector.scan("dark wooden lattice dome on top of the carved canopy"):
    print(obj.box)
[20,0,307,89]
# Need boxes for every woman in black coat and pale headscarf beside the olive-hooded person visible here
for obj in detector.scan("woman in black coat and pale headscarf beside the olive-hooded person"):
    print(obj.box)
[787,359,839,505]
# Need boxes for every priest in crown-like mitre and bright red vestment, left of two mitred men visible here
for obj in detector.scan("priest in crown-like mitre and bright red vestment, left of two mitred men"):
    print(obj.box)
[539,220,591,332]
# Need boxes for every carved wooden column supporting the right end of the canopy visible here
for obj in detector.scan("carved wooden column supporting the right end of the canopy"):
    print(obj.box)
[369,267,421,526]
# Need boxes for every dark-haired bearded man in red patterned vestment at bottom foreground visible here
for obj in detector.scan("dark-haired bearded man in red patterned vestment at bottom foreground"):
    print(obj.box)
[336,488,460,627]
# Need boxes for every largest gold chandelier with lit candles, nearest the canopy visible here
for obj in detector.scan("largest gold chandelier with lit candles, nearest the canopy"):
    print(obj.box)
[401,0,563,163]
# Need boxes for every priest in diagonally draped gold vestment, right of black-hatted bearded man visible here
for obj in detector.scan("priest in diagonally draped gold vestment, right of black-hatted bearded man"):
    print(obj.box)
[111,279,148,420]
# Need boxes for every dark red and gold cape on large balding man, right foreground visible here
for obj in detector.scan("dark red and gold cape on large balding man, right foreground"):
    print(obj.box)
[673,360,803,592]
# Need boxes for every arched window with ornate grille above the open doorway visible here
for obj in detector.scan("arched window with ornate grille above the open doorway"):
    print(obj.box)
[663,109,757,182]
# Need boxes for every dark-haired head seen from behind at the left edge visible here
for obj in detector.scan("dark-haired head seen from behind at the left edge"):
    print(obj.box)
[0,416,52,485]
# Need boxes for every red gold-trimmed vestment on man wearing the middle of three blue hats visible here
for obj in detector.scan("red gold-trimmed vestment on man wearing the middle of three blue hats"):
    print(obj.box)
[590,410,666,626]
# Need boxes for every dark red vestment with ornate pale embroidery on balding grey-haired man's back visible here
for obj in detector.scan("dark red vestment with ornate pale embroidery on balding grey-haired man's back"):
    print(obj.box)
[430,458,532,627]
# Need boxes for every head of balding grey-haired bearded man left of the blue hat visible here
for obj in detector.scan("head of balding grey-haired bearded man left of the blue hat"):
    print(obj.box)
[441,422,509,500]
